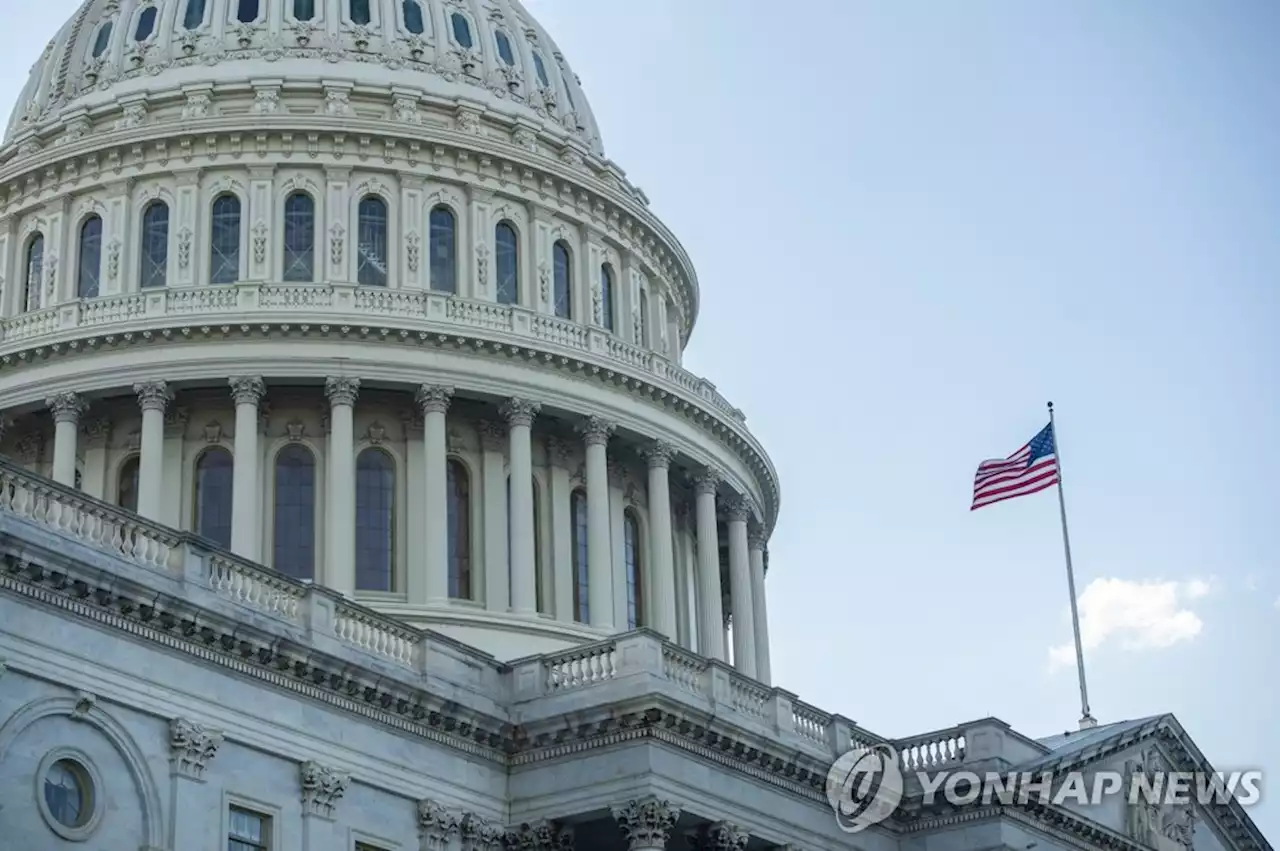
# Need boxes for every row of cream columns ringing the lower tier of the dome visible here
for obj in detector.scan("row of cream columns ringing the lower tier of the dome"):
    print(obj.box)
[37,376,771,682]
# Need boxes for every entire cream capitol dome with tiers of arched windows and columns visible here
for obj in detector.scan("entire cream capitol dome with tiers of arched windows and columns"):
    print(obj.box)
[0,0,778,665]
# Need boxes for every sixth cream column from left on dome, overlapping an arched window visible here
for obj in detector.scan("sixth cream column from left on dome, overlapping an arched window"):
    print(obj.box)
[502,398,543,614]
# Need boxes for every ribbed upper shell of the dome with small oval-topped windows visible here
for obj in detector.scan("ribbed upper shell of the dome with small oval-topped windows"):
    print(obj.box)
[5,0,603,155]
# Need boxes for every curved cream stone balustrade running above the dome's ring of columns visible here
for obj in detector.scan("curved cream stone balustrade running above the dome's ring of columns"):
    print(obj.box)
[0,283,746,424]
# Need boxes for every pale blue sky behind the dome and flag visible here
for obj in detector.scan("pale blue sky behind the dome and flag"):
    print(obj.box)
[0,0,1280,839]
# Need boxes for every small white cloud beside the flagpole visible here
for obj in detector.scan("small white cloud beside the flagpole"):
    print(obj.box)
[1048,578,1213,668]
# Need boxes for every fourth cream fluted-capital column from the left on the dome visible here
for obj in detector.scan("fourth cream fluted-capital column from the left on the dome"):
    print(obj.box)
[324,376,360,596]
